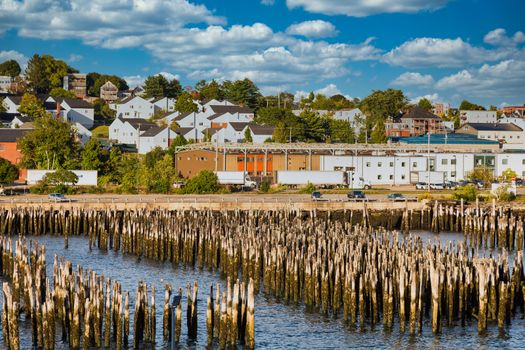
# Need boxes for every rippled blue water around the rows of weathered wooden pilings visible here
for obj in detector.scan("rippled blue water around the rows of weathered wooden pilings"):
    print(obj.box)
[0,234,525,349]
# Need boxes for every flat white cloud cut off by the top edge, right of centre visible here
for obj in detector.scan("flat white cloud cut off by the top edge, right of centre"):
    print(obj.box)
[286,0,448,17]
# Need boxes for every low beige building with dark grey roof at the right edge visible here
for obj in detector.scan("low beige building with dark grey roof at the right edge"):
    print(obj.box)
[456,123,524,144]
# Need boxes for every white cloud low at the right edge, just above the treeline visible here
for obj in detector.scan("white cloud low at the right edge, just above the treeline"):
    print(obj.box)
[436,59,525,102]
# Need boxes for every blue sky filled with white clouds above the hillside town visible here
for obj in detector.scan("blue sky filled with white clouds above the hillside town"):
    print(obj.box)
[0,0,525,106]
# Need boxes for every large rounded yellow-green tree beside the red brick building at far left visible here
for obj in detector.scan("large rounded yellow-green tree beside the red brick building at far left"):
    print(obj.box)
[19,115,79,169]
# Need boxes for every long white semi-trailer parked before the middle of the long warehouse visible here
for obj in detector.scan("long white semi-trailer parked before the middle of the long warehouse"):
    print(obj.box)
[277,170,347,186]
